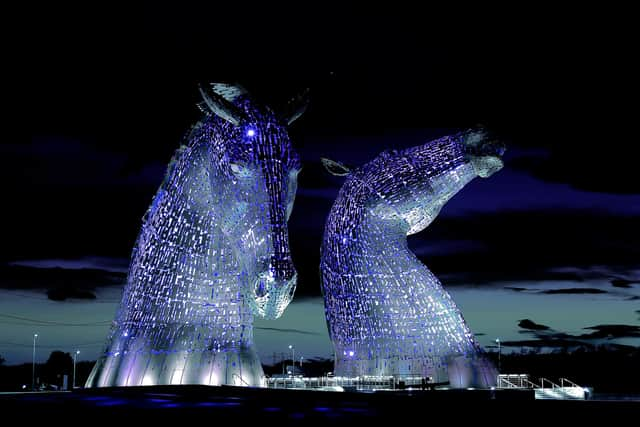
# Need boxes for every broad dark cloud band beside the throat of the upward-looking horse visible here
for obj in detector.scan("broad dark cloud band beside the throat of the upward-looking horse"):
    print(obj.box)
[410,210,640,283]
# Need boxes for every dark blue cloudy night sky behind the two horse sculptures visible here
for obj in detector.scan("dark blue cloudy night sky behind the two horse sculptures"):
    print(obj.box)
[0,2,640,363]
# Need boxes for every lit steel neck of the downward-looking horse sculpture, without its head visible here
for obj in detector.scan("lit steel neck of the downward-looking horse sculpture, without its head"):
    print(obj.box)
[89,133,263,386]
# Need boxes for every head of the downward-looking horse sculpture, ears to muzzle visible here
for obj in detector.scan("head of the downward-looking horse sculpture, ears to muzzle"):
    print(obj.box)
[192,84,306,318]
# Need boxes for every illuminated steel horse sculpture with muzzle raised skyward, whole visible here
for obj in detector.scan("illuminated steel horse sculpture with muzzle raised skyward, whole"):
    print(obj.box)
[321,131,504,387]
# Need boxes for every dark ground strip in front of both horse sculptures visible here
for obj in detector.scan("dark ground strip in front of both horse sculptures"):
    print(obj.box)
[0,386,639,425]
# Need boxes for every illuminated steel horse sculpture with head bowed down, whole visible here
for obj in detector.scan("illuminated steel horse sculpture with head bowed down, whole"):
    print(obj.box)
[87,84,306,387]
